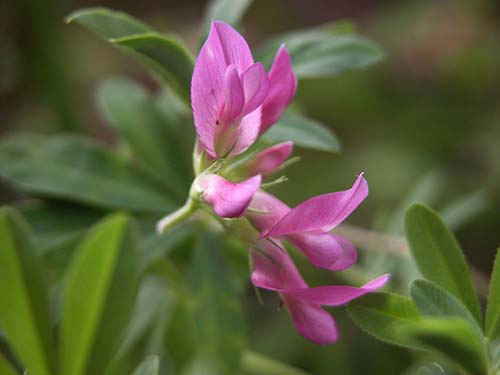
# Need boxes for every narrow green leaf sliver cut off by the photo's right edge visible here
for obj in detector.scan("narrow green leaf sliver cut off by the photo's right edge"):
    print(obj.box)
[485,249,500,341]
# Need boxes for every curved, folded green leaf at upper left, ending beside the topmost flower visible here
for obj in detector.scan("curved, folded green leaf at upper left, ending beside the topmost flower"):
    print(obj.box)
[66,8,194,104]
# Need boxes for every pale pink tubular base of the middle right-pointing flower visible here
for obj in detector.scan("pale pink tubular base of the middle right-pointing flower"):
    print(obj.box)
[246,190,290,232]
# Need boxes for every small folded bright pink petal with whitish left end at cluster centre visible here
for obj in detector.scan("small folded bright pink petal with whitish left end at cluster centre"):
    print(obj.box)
[200,174,261,218]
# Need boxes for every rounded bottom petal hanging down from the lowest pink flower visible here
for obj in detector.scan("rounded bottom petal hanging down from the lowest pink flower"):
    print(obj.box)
[282,295,338,345]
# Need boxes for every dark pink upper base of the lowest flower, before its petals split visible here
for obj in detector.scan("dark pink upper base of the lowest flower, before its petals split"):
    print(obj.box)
[251,239,307,291]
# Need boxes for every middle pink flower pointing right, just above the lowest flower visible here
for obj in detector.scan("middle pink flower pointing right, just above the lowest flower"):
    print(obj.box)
[246,174,368,271]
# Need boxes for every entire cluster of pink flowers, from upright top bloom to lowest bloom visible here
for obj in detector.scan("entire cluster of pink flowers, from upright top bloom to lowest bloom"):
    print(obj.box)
[191,21,389,345]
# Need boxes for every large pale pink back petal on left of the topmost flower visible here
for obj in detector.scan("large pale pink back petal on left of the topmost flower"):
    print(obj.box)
[191,22,253,157]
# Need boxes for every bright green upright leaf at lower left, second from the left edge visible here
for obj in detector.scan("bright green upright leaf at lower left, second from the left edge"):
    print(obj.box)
[60,214,143,374]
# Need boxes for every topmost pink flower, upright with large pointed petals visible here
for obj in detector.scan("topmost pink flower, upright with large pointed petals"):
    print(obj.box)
[191,21,297,157]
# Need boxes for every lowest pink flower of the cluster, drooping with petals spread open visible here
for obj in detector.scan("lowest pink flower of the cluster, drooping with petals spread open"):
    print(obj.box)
[252,240,390,345]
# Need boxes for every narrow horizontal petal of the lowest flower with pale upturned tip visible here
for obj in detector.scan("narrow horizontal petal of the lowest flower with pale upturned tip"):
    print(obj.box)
[282,274,390,306]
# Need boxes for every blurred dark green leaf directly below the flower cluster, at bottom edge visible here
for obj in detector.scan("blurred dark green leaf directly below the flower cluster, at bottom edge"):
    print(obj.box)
[188,234,246,375]
